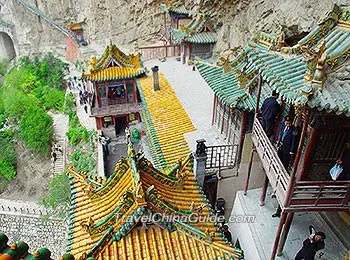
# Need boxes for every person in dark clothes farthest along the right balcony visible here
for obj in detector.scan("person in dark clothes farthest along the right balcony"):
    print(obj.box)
[261,90,280,138]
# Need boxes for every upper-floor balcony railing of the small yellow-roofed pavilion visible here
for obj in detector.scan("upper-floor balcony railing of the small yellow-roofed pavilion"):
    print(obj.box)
[91,103,142,117]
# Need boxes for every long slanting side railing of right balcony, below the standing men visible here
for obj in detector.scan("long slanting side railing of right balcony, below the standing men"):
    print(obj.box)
[252,118,290,206]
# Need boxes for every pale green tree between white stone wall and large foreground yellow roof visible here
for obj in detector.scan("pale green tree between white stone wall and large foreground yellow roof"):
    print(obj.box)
[40,173,71,218]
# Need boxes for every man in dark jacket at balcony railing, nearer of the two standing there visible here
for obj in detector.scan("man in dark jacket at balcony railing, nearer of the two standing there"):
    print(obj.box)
[277,116,298,169]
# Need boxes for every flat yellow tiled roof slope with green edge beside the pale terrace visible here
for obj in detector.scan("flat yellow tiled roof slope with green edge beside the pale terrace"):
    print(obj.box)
[139,73,195,169]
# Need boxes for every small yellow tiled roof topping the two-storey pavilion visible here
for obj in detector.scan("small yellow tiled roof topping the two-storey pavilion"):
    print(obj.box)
[82,43,145,81]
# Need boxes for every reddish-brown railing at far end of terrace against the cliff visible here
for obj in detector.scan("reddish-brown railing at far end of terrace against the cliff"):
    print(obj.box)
[140,45,180,60]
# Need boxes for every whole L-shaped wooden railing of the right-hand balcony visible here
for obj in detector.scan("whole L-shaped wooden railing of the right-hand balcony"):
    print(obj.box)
[252,118,350,211]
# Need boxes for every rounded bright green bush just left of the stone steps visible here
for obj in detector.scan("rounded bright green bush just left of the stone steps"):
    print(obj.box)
[19,107,53,156]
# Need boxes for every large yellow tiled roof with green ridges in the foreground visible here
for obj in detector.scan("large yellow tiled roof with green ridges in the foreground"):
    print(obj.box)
[67,144,242,260]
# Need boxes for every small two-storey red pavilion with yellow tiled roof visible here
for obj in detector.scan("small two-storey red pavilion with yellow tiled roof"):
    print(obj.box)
[82,43,145,135]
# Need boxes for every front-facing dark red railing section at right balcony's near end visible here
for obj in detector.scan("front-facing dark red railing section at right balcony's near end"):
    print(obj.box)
[288,181,350,211]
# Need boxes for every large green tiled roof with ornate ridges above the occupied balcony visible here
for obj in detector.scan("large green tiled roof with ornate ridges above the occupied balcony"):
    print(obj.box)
[245,5,350,115]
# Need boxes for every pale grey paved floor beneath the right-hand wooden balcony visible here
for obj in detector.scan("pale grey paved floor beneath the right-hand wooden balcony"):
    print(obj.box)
[228,189,346,260]
